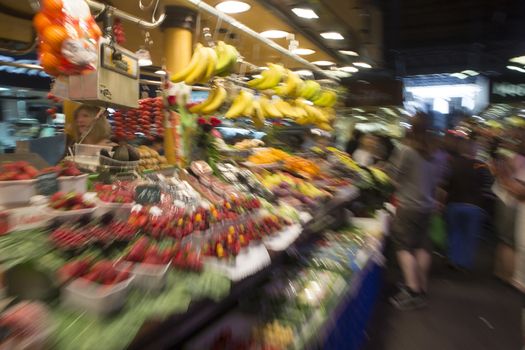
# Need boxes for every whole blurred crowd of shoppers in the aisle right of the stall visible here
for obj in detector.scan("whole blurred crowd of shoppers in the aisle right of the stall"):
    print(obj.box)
[346,113,525,310]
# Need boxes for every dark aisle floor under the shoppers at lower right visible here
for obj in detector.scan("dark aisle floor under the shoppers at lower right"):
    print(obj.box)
[364,243,523,350]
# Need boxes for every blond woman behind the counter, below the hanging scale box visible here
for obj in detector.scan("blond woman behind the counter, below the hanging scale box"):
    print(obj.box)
[67,105,112,147]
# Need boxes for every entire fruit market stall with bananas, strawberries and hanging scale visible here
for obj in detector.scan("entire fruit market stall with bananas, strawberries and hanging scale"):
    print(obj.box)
[0,1,392,349]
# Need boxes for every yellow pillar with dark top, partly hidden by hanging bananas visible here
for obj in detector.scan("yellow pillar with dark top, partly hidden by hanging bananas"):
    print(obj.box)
[162,6,197,165]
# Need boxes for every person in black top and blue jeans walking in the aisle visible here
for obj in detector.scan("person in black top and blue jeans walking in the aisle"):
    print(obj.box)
[443,137,493,269]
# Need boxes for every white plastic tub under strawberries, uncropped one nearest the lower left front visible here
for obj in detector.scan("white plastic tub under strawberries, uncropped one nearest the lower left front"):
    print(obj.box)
[61,276,135,315]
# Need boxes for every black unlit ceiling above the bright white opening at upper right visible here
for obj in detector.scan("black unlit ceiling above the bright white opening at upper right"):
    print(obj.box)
[383,0,525,76]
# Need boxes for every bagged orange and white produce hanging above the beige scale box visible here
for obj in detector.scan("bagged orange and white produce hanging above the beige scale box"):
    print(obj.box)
[33,0,102,76]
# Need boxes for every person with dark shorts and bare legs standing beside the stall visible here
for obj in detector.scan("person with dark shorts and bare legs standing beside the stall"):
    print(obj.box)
[384,113,442,310]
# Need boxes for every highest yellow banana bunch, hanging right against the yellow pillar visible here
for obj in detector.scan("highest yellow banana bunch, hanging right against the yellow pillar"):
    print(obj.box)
[171,41,239,85]
